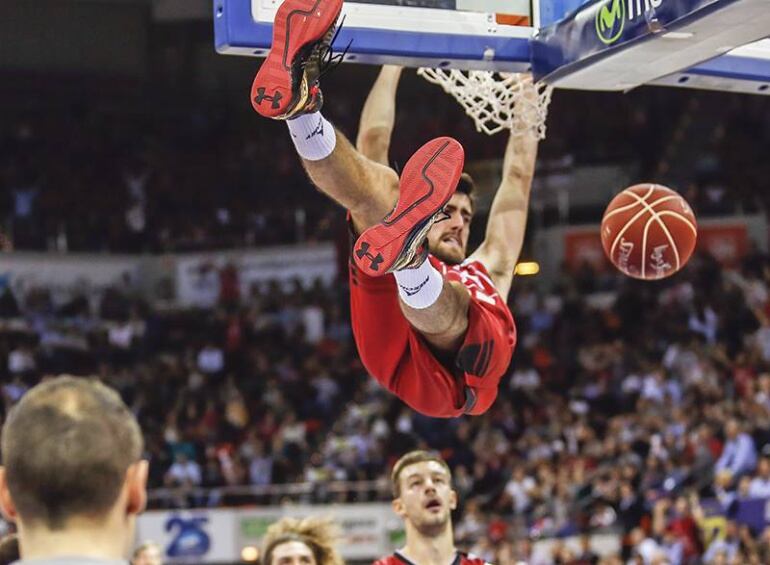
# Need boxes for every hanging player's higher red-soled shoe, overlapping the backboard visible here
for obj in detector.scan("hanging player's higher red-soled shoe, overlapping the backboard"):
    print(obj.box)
[251,0,342,120]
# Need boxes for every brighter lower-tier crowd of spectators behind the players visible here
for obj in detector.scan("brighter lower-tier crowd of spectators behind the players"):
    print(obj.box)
[0,240,770,564]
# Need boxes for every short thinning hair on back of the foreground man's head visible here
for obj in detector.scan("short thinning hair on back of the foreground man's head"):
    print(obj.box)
[2,377,144,530]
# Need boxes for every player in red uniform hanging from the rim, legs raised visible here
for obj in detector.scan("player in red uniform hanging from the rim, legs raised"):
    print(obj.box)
[251,0,538,417]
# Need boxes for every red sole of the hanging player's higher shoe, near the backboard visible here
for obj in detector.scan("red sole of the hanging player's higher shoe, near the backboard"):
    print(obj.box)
[251,0,342,118]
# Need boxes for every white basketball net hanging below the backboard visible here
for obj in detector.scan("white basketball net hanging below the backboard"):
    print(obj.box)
[417,67,553,139]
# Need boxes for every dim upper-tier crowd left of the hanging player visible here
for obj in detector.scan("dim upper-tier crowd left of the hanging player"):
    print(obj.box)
[0,107,340,253]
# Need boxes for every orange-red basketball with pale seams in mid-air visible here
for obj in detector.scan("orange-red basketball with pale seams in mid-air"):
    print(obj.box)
[601,184,698,280]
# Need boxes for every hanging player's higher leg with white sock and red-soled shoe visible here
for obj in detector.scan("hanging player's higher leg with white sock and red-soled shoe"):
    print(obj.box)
[251,0,398,231]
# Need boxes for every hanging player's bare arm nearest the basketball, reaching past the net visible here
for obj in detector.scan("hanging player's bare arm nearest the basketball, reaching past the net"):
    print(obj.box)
[470,124,538,299]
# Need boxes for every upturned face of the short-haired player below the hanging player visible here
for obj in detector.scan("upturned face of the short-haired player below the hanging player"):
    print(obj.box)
[393,461,457,537]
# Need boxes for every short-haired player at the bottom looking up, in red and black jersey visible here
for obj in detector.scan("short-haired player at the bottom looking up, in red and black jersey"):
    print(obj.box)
[374,451,488,565]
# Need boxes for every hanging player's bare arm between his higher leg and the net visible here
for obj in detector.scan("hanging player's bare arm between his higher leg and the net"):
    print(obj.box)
[356,65,403,165]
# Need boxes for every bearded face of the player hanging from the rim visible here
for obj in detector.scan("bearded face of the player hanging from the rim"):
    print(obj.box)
[428,192,473,265]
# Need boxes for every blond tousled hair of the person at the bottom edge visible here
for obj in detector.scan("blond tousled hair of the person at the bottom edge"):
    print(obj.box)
[262,517,345,565]
